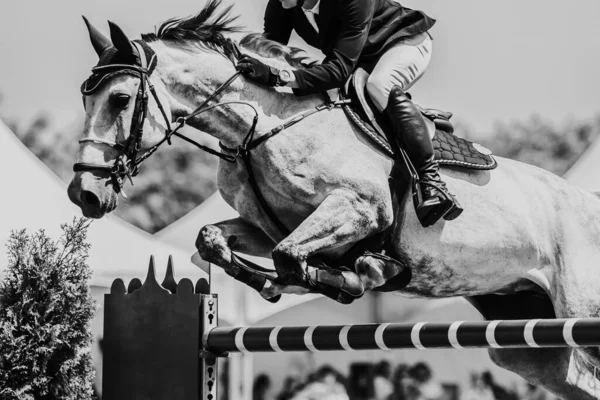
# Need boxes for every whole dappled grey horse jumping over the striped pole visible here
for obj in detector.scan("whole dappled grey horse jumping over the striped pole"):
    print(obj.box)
[68,0,600,399]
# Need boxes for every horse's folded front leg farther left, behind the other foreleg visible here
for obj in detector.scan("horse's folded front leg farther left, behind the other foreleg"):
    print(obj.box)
[192,218,309,301]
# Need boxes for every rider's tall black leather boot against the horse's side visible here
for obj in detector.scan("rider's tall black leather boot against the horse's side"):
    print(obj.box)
[385,86,463,227]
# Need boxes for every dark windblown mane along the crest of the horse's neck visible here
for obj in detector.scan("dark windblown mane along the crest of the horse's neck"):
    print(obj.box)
[142,0,308,68]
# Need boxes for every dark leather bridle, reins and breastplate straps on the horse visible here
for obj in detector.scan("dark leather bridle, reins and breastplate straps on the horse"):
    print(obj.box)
[73,42,350,235]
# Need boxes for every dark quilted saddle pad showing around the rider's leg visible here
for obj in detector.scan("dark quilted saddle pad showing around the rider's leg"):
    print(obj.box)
[343,105,498,170]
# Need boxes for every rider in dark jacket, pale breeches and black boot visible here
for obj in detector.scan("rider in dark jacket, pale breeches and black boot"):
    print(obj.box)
[237,0,462,227]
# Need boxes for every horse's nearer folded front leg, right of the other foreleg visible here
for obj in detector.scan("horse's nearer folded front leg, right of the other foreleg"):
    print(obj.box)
[273,189,401,303]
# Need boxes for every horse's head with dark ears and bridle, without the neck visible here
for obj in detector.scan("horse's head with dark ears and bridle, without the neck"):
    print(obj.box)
[68,17,172,218]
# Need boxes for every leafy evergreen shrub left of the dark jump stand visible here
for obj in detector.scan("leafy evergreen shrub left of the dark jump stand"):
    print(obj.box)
[0,218,95,400]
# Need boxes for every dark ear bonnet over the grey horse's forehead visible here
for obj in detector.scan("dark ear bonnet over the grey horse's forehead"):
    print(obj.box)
[81,23,157,95]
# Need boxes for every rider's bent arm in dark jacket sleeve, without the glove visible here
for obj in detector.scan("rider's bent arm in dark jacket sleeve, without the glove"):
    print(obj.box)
[288,0,373,95]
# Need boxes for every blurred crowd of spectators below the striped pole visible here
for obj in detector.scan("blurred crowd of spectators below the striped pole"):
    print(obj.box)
[252,361,558,400]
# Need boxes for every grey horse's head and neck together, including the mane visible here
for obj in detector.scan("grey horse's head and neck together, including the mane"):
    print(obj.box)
[68,0,322,218]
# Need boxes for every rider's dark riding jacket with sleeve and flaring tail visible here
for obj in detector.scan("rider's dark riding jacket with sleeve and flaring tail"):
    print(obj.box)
[263,0,435,95]
